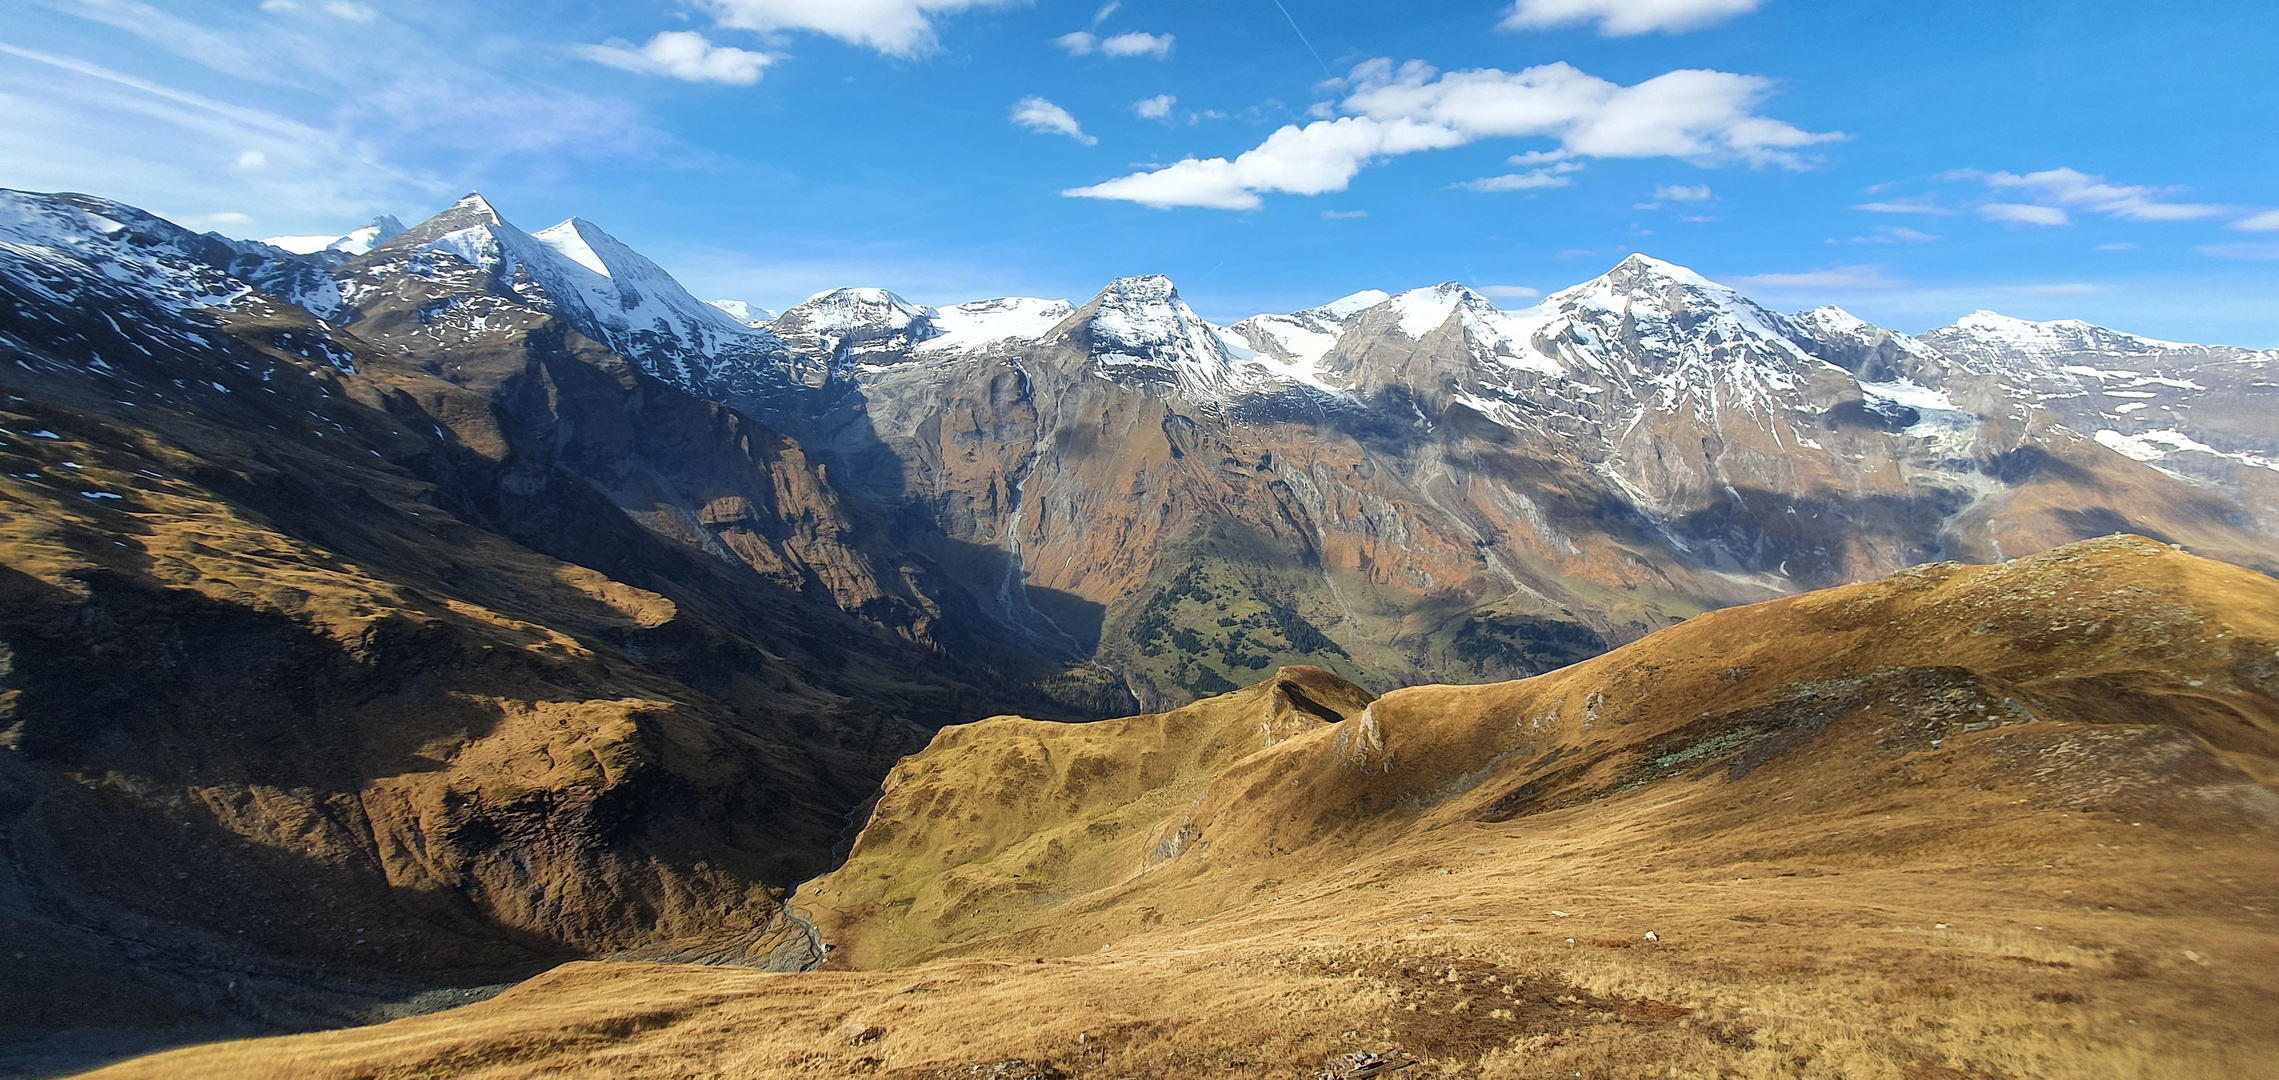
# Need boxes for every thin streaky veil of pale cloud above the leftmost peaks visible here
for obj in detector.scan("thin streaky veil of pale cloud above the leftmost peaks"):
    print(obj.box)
[0,0,677,235]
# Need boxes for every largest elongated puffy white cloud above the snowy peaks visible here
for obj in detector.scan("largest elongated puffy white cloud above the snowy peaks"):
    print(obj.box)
[1062,59,1841,210]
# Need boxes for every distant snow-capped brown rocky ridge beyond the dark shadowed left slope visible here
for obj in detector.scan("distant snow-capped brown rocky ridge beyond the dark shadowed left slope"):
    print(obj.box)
[205,196,2279,704]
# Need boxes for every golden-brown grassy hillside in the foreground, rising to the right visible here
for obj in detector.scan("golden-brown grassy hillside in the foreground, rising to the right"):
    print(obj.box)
[97,538,2279,1080]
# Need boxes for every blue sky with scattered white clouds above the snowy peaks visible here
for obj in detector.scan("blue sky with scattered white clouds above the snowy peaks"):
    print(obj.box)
[13,0,2279,346]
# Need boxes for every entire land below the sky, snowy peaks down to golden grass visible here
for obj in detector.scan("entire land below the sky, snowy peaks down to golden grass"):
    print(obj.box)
[0,191,2279,1078]
